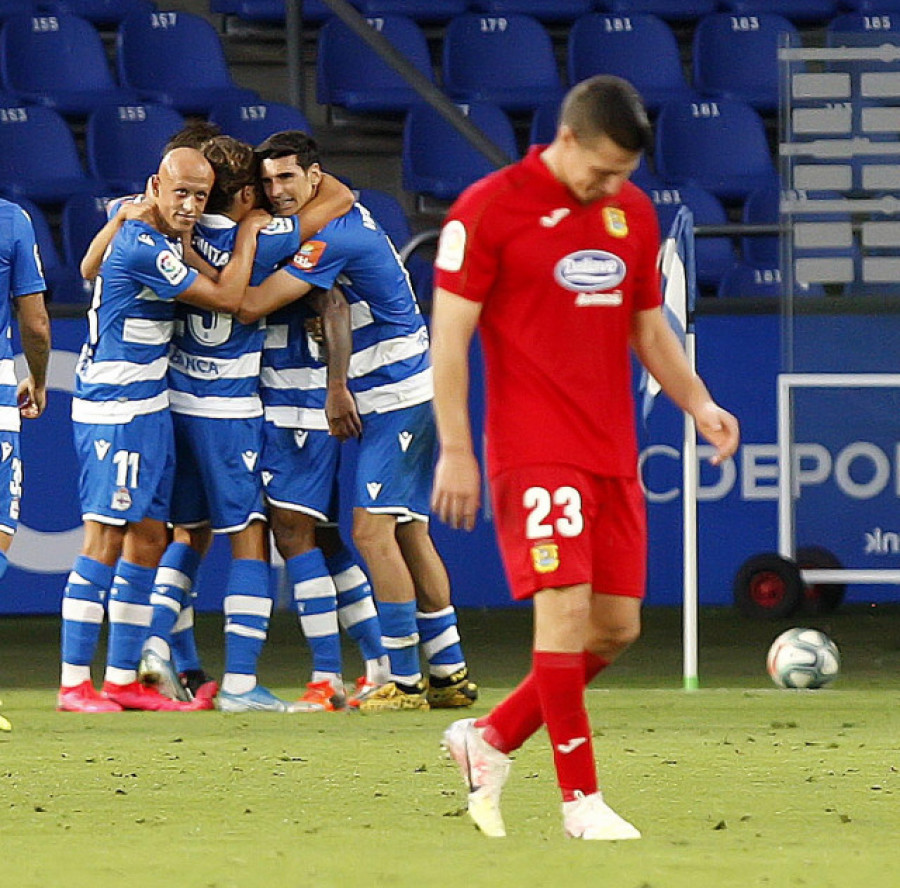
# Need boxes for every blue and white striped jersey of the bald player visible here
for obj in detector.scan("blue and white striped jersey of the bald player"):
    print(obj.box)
[72,221,197,424]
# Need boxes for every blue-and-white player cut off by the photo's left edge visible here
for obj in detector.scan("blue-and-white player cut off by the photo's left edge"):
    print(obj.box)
[0,199,50,731]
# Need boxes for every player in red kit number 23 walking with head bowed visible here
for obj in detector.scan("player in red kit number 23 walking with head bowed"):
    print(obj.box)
[432,76,739,839]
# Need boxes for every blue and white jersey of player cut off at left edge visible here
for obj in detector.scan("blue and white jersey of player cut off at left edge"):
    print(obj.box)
[0,199,46,432]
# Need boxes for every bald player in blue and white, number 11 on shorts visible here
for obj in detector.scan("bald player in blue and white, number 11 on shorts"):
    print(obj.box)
[58,148,269,712]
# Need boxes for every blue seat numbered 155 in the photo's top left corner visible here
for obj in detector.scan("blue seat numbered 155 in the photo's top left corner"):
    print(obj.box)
[0,14,137,117]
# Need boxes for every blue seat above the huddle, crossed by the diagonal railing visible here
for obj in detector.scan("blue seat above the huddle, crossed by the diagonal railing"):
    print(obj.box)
[316,15,434,113]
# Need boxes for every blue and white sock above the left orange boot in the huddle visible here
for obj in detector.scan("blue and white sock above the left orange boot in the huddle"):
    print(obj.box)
[285,549,341,675]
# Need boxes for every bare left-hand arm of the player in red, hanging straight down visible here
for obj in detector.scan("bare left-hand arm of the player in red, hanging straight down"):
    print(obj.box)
[431,287,481,530]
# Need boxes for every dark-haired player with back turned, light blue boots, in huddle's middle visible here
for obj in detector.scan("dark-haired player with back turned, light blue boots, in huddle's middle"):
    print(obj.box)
[142,136,353,712]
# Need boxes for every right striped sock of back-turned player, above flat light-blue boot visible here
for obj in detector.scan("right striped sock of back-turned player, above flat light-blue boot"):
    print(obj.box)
[223,558,272,677]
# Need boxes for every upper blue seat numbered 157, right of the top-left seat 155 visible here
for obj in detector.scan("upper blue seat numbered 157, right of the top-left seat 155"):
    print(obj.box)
[116,12,259,114]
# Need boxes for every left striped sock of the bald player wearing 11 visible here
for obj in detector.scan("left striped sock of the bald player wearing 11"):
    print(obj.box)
[62,555,113,684]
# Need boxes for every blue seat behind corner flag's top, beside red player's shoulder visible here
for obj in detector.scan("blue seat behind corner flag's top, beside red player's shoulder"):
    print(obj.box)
[647,185,736,292]
